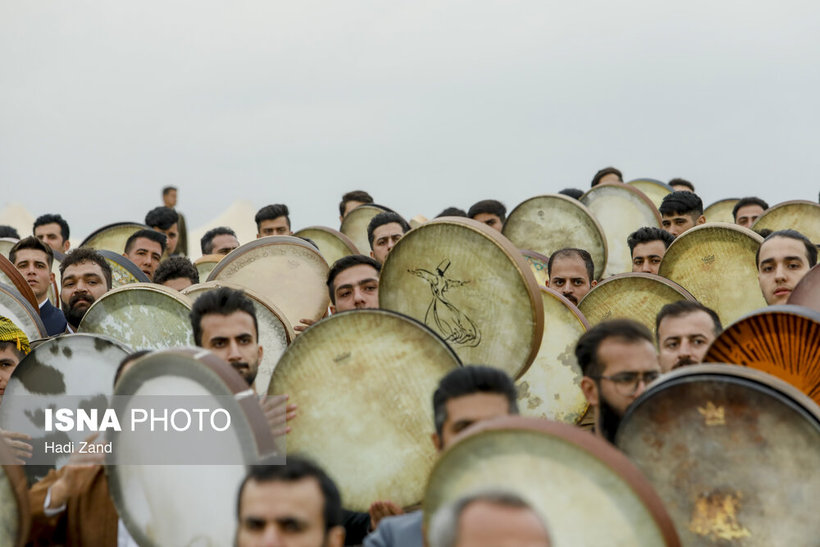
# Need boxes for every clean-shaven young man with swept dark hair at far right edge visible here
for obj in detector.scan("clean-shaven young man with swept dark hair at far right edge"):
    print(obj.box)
[755,230,817,305]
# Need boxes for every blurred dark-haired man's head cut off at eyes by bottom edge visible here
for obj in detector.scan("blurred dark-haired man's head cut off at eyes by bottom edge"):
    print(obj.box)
[235,456,345,547]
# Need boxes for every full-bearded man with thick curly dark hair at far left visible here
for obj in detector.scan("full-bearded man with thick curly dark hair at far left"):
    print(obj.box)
[60,248,111,332]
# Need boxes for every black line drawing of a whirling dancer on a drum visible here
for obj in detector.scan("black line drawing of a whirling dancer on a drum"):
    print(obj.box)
[407,258,481,348]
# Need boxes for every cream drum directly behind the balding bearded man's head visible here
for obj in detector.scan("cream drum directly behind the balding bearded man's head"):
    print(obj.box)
[503,194,608,279]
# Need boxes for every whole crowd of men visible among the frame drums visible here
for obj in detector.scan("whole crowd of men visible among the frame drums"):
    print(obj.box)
[0,172,817,546]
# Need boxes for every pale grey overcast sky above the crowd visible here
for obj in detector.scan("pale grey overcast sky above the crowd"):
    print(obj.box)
[0,0,820,239]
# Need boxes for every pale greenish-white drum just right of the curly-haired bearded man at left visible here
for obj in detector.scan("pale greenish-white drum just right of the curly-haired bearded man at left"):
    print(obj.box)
[78,283,194,351]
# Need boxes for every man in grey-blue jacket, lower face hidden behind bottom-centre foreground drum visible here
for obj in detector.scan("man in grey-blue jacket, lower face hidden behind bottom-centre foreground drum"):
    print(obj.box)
[364,365,518,547]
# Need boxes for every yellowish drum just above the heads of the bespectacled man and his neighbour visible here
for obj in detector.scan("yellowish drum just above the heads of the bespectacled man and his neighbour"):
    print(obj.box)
[578,272,695,334]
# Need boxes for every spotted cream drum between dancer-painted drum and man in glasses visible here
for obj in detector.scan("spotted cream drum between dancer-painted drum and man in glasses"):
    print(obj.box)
[516,287,589,424]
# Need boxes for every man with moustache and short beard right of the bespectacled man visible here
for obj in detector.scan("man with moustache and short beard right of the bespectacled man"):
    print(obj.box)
[655,300,723,372]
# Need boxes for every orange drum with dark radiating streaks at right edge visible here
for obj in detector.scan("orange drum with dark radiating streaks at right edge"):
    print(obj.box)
[704,305,820,403]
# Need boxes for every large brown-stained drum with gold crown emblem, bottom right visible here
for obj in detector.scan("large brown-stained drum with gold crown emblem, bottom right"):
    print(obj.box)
[616,365,820,546]
